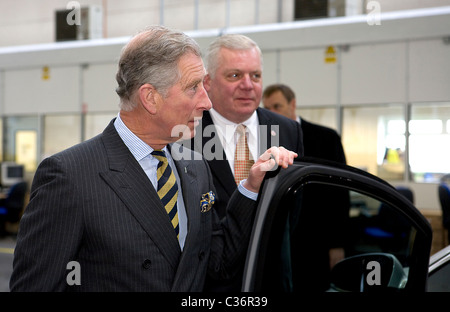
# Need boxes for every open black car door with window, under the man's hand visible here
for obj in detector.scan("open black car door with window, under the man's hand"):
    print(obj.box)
[242,158,432,293]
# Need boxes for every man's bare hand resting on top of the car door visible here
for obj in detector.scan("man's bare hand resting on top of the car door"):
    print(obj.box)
[243,146,298,193]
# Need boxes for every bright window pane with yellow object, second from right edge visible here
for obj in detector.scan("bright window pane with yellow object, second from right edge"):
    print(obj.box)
[342,105,406,180]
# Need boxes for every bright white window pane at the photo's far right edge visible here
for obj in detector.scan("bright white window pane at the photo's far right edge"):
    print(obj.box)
[409,103,450,182]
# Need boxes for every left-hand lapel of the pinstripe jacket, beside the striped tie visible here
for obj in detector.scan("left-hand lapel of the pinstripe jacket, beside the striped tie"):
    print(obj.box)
[100,122,181,268]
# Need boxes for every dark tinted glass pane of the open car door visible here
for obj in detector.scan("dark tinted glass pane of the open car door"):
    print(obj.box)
[263,183,416,292]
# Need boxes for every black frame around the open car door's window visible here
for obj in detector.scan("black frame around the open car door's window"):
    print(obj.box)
[242,157,432,291]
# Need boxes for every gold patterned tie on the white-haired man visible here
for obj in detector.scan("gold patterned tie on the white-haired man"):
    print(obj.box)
[234,124,254,184]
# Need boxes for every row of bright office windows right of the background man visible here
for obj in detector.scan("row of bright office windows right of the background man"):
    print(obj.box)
[306,102,450,183]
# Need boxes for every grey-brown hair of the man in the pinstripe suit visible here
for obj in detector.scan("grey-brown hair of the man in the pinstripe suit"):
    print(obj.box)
[116,26,201,111]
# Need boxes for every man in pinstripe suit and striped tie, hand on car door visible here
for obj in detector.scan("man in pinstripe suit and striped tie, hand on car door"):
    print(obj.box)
[10,26,295,291]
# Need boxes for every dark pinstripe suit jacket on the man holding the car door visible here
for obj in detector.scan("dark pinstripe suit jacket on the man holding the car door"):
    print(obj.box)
[10,122,255,291]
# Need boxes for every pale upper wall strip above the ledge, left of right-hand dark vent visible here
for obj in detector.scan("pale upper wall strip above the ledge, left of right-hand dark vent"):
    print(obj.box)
[0,0,293,46]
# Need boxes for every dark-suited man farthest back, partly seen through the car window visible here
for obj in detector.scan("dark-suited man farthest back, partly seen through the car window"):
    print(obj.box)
[262,84,350,291]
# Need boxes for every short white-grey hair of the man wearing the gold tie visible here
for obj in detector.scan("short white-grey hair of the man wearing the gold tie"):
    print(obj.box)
[206,34,263,77]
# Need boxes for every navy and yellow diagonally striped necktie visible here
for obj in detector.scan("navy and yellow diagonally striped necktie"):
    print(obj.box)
[152,150,180,237]
